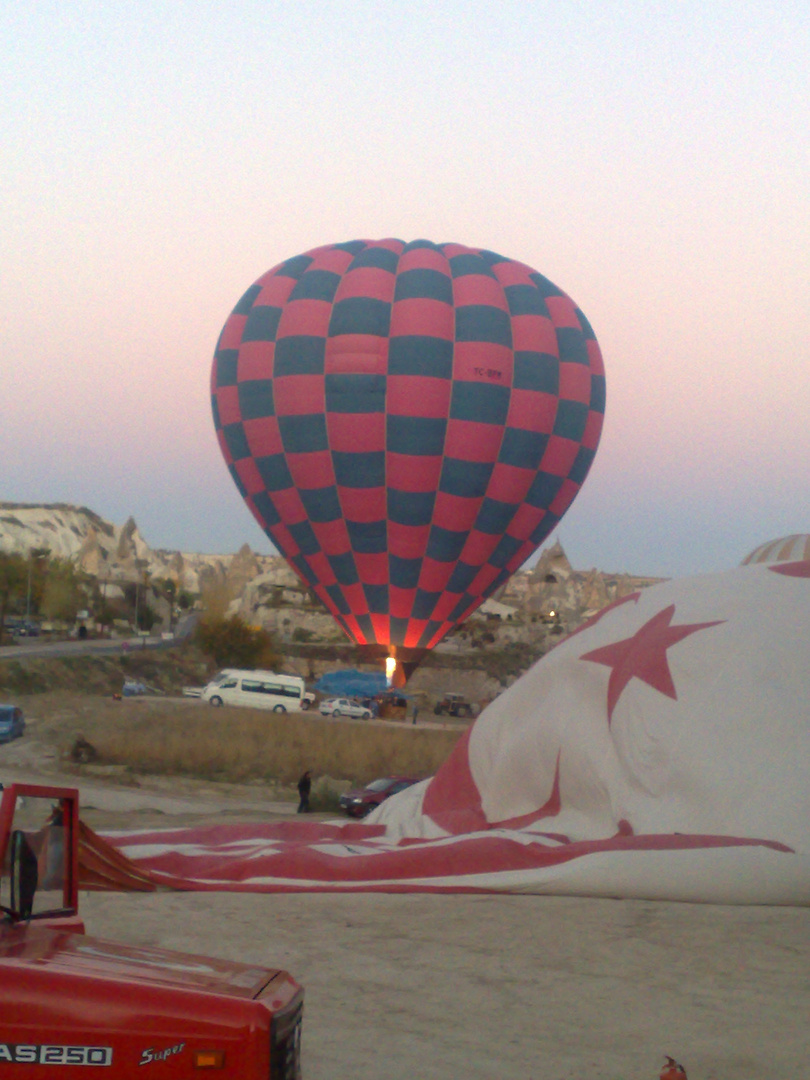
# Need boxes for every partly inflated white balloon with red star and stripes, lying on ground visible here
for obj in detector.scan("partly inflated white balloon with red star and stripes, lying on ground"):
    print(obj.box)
[104,562,810,904]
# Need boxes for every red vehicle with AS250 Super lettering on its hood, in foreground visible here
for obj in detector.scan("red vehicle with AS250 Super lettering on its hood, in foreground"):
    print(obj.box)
[0,784,303,1080]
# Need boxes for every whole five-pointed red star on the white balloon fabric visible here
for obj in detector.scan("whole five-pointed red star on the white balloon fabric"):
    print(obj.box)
[580,604,726,725]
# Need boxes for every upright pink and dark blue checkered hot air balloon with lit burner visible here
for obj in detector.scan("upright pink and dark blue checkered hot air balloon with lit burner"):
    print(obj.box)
[212,239,605,671]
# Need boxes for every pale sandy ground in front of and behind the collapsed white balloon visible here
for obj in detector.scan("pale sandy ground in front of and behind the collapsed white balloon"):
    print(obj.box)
[0,760,810,1080]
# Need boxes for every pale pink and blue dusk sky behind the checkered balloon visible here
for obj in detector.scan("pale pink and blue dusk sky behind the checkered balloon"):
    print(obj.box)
[0,0,810,576]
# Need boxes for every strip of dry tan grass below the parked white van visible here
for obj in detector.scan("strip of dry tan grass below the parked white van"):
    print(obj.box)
[6,690,465,785]
